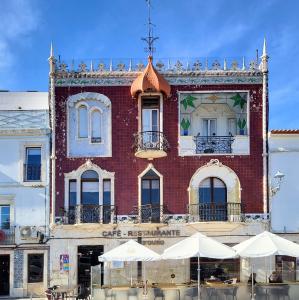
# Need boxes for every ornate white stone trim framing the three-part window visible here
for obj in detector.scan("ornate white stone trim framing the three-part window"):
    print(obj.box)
[64,159,115,210]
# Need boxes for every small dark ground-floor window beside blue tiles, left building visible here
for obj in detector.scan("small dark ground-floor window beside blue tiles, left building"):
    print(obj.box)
[28,254,44,283]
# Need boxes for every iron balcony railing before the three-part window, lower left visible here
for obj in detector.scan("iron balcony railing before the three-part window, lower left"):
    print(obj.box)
[63,204,117,224]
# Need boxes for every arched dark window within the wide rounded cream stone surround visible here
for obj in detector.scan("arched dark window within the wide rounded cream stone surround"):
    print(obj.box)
[198,177,227,221]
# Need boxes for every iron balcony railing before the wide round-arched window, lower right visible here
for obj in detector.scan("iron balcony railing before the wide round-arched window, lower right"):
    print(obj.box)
[188,203,244,222]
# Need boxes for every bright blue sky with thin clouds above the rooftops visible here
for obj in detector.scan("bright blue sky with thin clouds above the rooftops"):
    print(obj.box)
[0,0,299,128]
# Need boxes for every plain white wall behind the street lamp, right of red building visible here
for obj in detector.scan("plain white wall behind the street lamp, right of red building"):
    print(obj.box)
[269,134,299,232]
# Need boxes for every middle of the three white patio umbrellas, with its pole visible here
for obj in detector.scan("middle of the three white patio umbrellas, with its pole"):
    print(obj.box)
[161,232,236,299]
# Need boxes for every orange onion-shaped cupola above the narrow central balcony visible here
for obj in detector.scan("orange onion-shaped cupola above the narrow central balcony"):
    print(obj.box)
[131,56,170,98]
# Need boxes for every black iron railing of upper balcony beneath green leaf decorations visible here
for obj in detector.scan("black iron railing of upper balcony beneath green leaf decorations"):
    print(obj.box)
[194,135,234,154]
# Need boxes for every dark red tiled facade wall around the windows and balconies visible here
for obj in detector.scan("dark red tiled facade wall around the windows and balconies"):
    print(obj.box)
[55,84,263,214]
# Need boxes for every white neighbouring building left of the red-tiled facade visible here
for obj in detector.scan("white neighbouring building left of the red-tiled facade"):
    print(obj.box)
[0,92,50,297]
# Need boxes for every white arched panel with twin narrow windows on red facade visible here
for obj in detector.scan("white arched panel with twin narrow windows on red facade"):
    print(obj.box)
[68,93,112,157]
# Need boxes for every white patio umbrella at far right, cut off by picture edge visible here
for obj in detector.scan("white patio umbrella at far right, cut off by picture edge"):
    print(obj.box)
[233,231,299,299]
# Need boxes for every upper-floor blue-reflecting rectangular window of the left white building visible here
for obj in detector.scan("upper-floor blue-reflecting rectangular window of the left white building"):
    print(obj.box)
[24,147,41,181]
